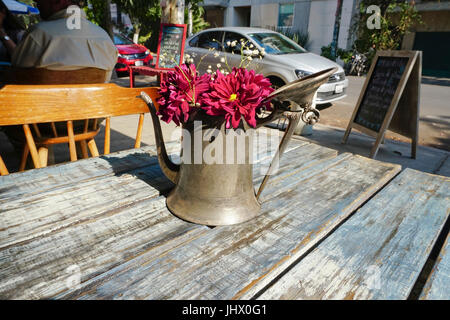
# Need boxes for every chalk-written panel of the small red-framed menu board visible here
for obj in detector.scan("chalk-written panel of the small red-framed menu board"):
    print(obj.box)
[158,26,184,68]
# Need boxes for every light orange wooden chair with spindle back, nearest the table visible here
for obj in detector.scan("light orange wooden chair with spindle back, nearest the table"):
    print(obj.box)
[0,84,159,175]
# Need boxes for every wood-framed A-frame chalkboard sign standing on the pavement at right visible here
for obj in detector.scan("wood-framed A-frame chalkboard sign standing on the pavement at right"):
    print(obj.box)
[343,51,422,158]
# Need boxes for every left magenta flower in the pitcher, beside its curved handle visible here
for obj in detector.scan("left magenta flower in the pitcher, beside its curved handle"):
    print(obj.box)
[157,64,211,126]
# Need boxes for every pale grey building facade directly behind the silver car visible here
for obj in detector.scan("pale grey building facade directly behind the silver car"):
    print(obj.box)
[202,0,357,53]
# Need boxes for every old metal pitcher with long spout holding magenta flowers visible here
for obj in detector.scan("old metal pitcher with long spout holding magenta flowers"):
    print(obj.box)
[141,68,336,226]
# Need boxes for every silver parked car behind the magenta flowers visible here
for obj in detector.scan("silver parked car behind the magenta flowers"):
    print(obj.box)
[185,27,348,104]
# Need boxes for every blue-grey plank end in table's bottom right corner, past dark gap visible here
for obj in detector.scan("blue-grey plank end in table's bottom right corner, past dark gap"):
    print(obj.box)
[420,231,450,300]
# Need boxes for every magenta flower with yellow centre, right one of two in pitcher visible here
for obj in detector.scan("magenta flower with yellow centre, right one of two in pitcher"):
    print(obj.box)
[202,68,273,129]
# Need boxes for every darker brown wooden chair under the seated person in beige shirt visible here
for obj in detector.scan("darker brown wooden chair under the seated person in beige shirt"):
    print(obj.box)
[1,68,107,171]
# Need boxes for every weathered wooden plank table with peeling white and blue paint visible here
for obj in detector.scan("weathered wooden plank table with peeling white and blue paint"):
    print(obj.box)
[0,133,450,299]
